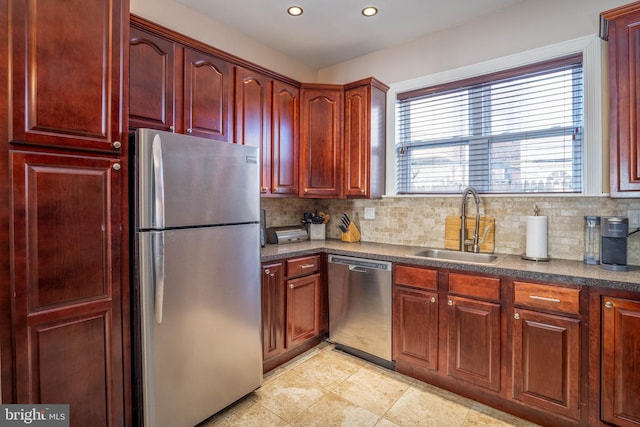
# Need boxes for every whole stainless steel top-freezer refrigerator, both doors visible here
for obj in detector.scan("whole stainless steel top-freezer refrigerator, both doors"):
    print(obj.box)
[133,129,262,427]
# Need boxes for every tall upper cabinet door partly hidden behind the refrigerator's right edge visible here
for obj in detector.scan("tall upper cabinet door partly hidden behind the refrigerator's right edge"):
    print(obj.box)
[234,67,271,193]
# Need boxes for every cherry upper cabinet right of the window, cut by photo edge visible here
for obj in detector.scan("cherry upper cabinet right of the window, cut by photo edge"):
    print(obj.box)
[600,2,640,197]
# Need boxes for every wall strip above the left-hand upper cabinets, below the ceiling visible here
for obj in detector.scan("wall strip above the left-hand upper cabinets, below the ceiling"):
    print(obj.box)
[130,0,317,82]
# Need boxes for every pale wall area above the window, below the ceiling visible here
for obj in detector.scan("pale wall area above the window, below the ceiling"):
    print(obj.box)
[318,0,630,84]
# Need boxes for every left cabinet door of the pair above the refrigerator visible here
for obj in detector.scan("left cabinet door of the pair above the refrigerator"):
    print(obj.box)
[129,27,178,131]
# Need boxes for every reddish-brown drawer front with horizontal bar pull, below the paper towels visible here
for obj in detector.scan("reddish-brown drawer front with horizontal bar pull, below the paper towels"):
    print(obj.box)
[513,282,580,314]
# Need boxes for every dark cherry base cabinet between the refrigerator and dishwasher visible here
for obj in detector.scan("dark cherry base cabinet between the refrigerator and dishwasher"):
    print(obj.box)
[262,255,327,372]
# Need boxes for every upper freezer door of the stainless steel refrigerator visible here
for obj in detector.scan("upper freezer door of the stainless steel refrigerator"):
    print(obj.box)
[135,129,260,230]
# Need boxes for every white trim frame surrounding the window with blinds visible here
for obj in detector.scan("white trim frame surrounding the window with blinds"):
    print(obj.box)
[386,35,608,197]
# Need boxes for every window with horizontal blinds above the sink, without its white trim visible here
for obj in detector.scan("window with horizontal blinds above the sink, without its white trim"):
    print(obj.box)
[396,55,583,194]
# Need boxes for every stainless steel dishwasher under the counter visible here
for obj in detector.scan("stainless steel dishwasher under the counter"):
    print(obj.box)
[329,255,393,367]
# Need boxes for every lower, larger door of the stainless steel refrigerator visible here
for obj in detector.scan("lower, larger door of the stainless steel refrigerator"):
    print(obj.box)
[138,224,262,427]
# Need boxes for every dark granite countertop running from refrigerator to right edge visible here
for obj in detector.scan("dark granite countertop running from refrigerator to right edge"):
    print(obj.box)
[261,240,640,292]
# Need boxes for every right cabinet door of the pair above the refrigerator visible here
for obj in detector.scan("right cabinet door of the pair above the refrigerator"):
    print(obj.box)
[184,48,233,142]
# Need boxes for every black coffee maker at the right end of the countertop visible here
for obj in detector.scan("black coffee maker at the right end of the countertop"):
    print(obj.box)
[600,216,629,271]
